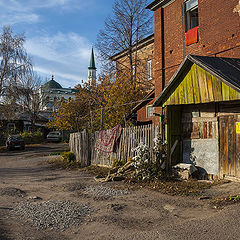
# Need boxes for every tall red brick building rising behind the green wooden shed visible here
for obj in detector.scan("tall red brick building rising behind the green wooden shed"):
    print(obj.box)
[147,0,240,119]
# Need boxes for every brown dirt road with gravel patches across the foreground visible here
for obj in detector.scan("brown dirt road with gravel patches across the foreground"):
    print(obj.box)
[0,144,240,240]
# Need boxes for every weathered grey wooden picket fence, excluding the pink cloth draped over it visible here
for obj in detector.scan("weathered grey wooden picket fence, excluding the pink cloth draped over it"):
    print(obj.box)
[69,124,158,167]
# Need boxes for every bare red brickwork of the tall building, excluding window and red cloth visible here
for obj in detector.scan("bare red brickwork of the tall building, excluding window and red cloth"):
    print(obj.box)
[153,0,240,97]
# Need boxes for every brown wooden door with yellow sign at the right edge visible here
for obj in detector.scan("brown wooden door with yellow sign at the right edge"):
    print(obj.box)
[219,114,240,177]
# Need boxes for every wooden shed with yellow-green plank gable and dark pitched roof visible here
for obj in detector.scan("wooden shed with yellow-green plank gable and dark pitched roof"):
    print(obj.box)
[153,55,240,178]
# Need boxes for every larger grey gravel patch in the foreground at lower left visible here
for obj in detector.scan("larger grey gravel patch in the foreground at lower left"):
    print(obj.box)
[13,201,91,231]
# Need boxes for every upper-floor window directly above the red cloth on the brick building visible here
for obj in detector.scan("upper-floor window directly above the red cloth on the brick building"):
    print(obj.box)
[184,0,198,32]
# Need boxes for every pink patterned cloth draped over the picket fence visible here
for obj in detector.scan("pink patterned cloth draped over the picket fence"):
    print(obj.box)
[95,125,122,153]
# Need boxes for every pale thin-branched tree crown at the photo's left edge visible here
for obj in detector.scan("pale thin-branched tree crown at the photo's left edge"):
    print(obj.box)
[0,26,32,96]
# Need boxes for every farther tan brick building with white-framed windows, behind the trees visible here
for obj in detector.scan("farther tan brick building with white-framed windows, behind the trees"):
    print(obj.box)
[111,34,155,125]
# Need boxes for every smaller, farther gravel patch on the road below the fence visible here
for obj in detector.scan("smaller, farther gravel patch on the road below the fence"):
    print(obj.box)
[83,186,129,198]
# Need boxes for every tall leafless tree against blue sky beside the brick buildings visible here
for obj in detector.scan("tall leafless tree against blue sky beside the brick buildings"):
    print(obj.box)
[97,0,152,79]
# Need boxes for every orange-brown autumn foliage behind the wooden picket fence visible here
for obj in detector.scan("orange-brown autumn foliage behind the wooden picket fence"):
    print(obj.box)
[48,73,145,131]
